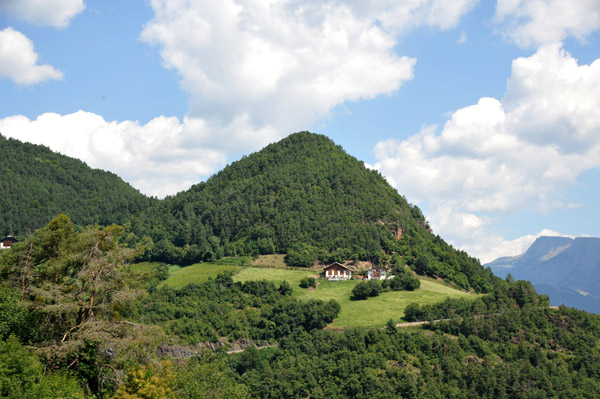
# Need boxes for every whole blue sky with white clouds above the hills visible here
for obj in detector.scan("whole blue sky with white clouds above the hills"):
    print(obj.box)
[0,0,600,262]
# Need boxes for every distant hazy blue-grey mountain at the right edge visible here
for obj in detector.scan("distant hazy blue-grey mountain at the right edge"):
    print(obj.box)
[485,237,600,313]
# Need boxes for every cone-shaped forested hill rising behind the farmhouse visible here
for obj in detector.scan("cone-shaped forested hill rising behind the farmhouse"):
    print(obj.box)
[133,132,493,291]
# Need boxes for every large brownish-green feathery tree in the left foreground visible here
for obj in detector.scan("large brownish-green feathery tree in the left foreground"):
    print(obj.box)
[0,215,163,393]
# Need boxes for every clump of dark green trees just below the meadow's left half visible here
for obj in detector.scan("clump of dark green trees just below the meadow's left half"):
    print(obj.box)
[133,273,340,344]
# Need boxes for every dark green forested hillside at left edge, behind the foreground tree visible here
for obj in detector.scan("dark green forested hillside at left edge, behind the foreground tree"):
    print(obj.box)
[0,135,153,236]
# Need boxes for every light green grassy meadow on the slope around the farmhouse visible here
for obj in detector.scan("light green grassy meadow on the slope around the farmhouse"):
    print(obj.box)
[162,263,477,329]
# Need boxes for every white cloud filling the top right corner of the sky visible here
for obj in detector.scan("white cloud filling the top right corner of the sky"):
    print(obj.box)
[494,0,600,47]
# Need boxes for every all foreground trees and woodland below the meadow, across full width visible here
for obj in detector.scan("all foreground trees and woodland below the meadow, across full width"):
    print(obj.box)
[0,215,600,399]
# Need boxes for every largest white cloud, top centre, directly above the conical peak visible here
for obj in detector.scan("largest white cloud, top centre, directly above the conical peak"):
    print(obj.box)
[141,0,474,145]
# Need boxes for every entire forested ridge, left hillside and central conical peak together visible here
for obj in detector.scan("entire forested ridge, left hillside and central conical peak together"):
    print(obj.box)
[0,132,494,292]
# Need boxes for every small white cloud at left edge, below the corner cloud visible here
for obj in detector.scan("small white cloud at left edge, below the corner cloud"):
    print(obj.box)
[0,27,63,85]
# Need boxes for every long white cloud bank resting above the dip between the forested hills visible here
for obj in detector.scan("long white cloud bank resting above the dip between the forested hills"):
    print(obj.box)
[0,111,278,197]
